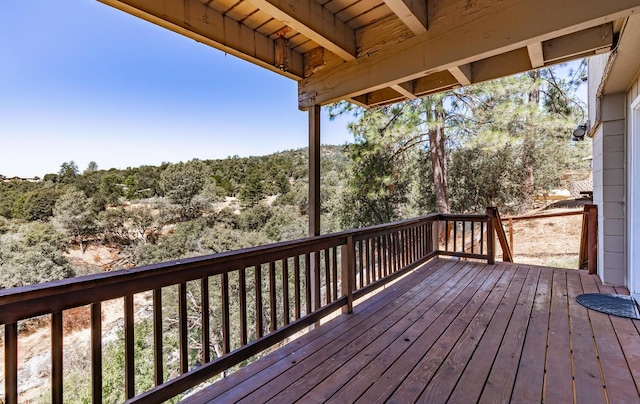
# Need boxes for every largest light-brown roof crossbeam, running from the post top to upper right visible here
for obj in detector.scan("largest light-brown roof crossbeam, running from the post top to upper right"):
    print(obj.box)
[298,0,640,109]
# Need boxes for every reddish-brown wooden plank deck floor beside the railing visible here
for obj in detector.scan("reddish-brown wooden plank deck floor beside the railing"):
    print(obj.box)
[185,259,640,404]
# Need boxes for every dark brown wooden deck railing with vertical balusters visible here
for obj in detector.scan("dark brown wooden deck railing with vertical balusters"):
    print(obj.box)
[0,211,495,403]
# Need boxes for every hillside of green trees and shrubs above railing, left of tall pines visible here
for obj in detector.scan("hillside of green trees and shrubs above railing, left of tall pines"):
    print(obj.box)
[0,146,347,288]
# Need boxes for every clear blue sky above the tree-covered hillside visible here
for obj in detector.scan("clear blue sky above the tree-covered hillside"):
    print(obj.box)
[0,0,351,177]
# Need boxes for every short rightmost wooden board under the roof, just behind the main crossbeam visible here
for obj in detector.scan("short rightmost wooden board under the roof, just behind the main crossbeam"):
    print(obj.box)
[542,22,613,62]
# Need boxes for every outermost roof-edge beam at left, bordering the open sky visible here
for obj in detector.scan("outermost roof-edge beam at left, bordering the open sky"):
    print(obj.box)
[98,0,303,80]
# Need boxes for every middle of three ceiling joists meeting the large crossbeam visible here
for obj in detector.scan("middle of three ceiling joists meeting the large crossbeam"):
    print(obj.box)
[248,0,356,60]
